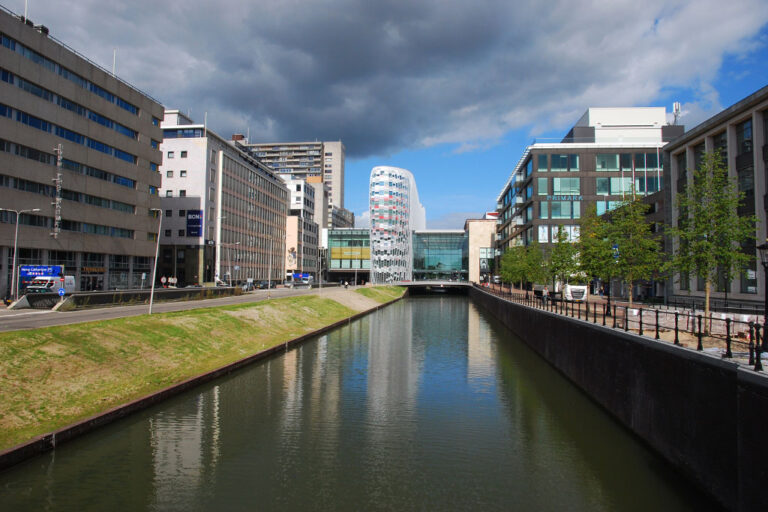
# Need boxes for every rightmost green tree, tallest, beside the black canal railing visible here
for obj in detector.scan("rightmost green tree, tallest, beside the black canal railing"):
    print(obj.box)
[668,151,757,322]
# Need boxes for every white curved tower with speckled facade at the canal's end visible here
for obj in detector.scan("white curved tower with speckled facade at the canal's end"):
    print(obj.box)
[370,166,427,283]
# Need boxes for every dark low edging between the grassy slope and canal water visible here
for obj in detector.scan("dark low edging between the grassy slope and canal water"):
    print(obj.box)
[0,289,408,471]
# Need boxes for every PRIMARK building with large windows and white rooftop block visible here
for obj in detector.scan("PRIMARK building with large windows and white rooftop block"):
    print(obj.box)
[497,107,684,258]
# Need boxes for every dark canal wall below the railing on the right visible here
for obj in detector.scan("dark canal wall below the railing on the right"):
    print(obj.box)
[470,288,768,511]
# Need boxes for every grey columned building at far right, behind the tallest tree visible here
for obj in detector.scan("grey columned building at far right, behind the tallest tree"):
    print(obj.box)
[664,87,768,305]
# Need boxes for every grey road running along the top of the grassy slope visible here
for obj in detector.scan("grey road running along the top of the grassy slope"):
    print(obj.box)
[0,288,338,332]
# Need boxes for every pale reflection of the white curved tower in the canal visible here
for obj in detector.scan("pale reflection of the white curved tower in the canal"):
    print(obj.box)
[367,303,424,431]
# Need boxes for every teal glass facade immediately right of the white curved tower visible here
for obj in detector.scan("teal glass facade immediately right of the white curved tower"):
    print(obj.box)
[413,231,469,281]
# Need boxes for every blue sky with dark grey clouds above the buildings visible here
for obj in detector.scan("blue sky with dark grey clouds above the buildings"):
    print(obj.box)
[10,0,768,229]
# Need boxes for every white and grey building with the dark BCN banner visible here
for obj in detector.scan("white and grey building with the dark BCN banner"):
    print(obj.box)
[158,110,288,284]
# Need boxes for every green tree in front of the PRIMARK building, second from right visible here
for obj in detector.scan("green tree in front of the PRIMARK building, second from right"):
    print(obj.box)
[607,194,661,307]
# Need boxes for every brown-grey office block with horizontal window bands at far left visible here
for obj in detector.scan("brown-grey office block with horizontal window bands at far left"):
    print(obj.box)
[0,10,163,296]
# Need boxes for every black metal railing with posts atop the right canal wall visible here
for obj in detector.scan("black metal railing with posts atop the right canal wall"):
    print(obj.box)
[474,284,768,371]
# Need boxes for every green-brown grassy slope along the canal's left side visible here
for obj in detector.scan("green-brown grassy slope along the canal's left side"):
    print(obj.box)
[0,295,355,450]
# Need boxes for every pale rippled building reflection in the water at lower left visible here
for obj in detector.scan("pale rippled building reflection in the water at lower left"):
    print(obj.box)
[149,386,220,510]
